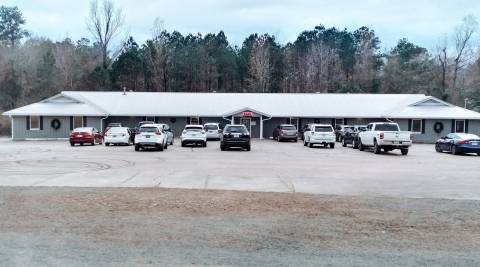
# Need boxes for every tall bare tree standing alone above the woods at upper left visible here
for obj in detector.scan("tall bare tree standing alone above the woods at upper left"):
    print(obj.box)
[87,0,125,68]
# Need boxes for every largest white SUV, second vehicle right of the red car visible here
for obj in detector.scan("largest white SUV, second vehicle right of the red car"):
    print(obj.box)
[135,124,168,151]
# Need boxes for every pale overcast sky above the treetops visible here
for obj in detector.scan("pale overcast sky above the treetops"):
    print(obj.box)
[2,0,480,49]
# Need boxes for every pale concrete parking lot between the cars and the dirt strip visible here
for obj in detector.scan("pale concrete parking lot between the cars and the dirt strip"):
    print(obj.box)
[0,140,480,199]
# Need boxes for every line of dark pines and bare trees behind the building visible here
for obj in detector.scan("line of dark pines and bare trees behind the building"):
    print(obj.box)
[0,0,480,114]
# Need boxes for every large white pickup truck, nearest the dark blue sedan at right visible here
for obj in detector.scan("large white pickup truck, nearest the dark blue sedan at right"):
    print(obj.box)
[358,122,412,155]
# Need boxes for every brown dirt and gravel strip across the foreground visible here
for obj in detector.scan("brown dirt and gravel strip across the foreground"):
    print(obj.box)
[0,187,480,266]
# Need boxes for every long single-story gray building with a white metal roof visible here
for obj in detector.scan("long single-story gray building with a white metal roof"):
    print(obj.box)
[3,91,480,142]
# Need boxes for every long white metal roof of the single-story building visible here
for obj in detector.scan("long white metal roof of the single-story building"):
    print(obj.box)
[3,91,480,119]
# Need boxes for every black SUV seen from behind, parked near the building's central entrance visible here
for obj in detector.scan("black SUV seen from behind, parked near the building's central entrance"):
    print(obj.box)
[220,124,251,151]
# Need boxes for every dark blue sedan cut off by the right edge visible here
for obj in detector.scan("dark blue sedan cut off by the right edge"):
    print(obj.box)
[435,133,480,156]
